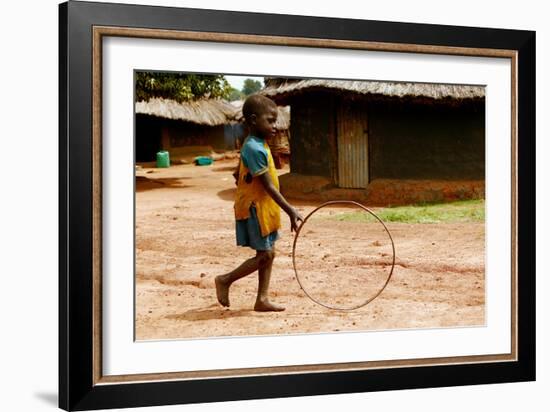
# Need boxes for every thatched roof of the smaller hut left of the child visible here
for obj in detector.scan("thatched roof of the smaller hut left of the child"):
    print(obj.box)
[136,98,237,126]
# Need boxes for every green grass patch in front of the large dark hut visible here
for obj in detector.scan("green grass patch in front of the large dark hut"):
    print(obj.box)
[329,199,485,223]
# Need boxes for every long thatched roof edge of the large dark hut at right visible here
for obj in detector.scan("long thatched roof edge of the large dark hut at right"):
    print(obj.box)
[261,78,485,101]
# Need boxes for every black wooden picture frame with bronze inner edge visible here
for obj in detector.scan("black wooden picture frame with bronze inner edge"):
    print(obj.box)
[59,1,535,410]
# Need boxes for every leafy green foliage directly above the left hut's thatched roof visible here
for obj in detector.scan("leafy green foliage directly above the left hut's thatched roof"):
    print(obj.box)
[136,72,231,103]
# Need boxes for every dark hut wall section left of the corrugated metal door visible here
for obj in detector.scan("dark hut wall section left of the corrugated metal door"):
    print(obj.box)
[290,92,337,179]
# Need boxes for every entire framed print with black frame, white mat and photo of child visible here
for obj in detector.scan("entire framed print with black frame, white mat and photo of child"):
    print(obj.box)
[59,1,535,410]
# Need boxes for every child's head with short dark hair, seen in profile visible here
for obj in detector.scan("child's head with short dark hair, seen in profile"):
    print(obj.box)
[243,94,277,139]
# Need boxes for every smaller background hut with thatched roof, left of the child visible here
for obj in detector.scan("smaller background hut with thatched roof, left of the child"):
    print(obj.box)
[135,98,237,162]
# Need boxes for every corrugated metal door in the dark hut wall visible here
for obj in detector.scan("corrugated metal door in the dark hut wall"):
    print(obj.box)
[337,102,369,188]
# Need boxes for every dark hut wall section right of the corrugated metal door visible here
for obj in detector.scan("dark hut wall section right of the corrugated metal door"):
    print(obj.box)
[369,102,485,181]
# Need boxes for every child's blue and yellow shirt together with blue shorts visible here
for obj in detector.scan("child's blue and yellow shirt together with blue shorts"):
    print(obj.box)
[234,135,281,250]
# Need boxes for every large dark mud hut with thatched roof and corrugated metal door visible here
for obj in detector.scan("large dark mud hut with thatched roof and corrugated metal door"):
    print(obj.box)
[262,78,485,204]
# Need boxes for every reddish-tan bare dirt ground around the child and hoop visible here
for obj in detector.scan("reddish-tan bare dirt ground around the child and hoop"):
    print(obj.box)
[136,160,485,340]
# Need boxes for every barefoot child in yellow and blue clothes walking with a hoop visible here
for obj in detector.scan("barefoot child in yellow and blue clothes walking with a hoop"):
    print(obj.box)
[215,94,303,312]
